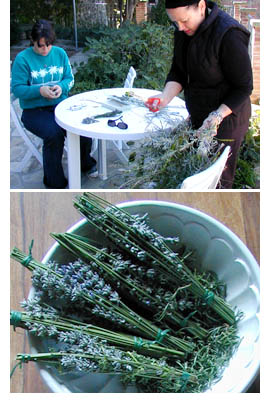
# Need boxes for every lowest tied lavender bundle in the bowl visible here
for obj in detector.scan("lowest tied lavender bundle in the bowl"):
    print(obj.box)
[16,332,197,392]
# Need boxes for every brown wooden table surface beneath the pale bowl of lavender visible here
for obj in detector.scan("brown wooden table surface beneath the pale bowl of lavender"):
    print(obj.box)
[10,191,260,393]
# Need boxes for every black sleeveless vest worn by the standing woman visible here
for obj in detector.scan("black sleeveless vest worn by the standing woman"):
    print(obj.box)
[175,2,251,136]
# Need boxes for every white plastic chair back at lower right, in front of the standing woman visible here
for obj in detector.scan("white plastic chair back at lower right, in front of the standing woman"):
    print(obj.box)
[181,146,231,190]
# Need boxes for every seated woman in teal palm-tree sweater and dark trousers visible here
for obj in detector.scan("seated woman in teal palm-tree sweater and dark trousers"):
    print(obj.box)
[12,20,96,189]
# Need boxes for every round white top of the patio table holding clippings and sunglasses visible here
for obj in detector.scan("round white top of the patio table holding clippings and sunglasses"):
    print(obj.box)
[55,88,188,140]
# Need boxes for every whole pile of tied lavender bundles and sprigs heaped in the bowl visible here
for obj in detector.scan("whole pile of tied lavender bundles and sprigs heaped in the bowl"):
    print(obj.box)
[11,193,243,393]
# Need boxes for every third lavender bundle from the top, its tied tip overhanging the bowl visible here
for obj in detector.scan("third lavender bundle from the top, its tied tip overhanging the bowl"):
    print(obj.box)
[11,248,194,353]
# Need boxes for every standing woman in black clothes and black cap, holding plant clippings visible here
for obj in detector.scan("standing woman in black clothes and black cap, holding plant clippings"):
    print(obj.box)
[146,0,253,188]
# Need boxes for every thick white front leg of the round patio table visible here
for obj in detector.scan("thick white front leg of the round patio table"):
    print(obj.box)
[67,131,81,189]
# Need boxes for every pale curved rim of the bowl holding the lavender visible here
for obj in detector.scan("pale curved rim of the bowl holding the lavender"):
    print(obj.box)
[37,200,260,393]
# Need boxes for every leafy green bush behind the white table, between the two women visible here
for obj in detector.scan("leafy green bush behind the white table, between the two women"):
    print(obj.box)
[71,23,173,94]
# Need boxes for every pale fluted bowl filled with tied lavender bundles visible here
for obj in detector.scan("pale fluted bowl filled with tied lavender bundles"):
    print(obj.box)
[10,193,260,393]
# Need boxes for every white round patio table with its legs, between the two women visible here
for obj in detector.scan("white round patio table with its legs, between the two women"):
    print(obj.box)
[55,88,188,189]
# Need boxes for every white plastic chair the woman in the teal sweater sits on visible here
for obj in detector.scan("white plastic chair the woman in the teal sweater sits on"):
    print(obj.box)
[10,93,43,172]
